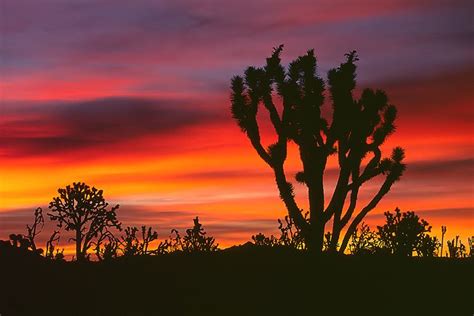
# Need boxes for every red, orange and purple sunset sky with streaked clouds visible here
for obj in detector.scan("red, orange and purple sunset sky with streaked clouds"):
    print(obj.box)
[0,0,474,246]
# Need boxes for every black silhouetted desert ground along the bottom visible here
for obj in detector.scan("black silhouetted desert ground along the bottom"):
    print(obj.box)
[0,249,474,316]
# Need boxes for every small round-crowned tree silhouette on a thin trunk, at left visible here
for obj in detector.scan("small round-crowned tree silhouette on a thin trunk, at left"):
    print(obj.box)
[48,182,121,261]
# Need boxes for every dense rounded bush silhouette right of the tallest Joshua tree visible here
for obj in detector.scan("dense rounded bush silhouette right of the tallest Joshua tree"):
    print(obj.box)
[377,208,437,257]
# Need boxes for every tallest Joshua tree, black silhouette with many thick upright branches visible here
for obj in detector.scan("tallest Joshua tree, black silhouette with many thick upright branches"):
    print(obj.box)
[231,45,405,252]
